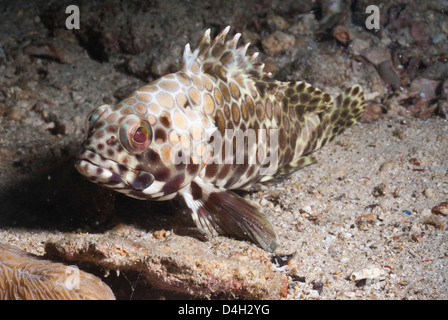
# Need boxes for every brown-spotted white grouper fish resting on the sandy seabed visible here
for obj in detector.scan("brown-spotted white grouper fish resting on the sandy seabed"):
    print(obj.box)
[75,26,364,252]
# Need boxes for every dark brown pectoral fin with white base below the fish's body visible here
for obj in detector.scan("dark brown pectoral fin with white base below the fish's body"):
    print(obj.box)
[182,178,277,252]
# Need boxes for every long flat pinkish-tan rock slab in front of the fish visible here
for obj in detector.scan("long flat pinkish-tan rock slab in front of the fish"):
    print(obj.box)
[45,232,288,299]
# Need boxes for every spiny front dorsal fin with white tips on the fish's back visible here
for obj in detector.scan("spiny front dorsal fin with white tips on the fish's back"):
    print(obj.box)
[182,26,270,79]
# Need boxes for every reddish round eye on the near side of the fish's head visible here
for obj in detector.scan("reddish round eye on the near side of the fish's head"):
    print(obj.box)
[120,116,152,153]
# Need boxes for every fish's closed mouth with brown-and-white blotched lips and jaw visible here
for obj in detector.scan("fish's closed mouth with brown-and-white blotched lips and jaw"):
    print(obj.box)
[75,149,154,192]
